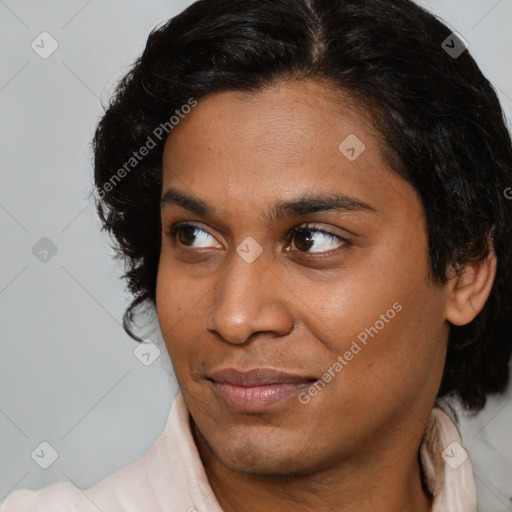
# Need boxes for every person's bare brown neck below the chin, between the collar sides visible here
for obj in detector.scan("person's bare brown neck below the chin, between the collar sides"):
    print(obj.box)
[191,422,432,512]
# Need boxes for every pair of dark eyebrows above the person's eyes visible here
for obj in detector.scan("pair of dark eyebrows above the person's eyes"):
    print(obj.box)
[160,188,378,225]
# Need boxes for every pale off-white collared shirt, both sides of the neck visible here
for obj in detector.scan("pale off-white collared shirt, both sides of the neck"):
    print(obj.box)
[0,393,477,512]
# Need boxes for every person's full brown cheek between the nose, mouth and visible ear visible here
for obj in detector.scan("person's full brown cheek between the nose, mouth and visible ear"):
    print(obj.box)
[298,243,448,408]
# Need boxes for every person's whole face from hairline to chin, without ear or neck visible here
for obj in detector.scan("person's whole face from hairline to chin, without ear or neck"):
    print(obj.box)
[157,81,448,475]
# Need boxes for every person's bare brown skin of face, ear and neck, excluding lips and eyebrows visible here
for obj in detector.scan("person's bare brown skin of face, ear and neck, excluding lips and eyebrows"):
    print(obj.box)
[157,81,495,512]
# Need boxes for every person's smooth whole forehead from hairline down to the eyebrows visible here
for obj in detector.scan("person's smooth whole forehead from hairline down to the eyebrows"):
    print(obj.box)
[163,81,420,221]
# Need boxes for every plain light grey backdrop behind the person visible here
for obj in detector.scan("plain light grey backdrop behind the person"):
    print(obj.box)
[0,0,512,512]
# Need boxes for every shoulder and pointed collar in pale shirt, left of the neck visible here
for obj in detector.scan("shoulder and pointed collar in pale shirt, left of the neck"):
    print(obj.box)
[0,399,194,512]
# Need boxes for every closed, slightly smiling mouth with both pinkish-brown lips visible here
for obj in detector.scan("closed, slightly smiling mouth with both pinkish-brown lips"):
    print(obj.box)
[207,368,317,412]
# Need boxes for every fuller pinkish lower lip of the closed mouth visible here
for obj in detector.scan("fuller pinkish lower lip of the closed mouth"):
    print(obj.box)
[211,381,312,412]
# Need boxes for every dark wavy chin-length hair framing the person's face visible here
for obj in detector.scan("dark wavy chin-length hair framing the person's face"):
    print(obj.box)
[93,0,512,411]
